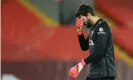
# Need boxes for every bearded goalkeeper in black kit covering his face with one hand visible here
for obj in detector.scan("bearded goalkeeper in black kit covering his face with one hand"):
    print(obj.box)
[69,4,116,80]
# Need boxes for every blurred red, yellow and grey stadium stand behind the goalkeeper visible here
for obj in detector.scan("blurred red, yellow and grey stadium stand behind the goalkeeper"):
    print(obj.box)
[1,0,133,80]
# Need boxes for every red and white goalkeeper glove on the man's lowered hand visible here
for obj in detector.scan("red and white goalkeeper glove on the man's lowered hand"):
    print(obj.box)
[69,59,86,78]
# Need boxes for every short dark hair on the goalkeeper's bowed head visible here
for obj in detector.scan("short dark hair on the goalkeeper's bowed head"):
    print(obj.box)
[75,4,95,17]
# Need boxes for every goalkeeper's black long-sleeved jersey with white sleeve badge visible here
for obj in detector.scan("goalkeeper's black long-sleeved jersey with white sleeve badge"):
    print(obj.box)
[78,19,116,78]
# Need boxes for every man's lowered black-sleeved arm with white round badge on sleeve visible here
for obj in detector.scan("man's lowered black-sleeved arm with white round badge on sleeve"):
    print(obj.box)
[84,27,108,64]
